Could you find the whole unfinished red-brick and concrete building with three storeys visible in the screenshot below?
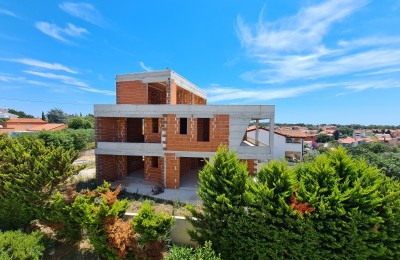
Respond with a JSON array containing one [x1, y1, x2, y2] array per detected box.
[[94, 69, 275, 189]]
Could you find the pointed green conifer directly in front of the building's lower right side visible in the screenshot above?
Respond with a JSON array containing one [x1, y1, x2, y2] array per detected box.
[[189, 147, 248, 247]]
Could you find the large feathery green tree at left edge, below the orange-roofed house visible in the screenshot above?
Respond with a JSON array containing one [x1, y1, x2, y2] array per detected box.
[[0, 136, 84, 229]]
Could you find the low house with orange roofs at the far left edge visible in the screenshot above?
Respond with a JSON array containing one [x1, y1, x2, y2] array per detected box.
[[0, 118, 67, 136]]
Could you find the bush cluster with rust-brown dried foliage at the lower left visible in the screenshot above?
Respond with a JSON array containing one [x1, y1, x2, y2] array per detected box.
[[47, 183, 173, 259]]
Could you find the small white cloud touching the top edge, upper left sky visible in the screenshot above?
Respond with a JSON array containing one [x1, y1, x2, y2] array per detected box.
[[59, 2, 104, 26]]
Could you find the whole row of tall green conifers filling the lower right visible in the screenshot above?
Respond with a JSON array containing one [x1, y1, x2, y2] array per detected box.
[[190, 148, 400, 259]]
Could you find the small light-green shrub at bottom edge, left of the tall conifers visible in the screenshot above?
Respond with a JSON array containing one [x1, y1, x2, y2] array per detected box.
[[165, 242, 221, 260]]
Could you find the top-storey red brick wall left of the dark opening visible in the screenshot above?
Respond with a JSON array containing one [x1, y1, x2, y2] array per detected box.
[[117, 80, 148, 104]]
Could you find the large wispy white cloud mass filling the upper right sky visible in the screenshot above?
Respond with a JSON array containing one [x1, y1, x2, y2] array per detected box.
[[237, 0, 400, 88]]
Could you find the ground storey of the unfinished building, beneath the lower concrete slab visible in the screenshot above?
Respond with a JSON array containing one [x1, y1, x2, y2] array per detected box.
[[96, 153, 257, 190]]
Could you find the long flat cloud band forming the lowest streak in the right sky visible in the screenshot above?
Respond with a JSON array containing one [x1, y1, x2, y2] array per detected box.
[[242, 48, 400, 84]]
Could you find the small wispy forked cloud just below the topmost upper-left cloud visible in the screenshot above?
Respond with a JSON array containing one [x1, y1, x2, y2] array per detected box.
[[35, 22, 88, 43]]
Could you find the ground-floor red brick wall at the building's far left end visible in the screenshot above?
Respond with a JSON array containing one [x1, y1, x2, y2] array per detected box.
[[96, 154, 127, 183]]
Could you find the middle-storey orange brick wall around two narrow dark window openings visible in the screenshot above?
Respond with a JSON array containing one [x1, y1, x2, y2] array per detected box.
[[164, 115, 229, 152]]
